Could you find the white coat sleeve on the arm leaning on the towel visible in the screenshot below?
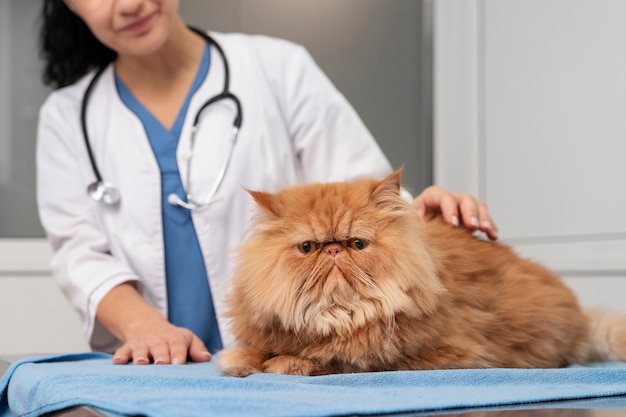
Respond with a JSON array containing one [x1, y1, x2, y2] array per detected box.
[[37, 92, 137, 349]]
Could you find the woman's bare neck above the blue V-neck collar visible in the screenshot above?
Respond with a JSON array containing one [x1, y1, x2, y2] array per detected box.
[[115, 19, 205, 86]]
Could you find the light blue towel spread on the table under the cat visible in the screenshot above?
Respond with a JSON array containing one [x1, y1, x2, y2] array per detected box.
[[0, 353, 626, 417]]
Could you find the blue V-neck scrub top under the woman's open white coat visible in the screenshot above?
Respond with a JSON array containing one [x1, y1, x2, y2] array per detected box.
[[115, 44, 222, 353]]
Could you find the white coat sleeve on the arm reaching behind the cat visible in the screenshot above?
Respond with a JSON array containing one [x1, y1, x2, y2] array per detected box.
[[264, 46, 391, 181]]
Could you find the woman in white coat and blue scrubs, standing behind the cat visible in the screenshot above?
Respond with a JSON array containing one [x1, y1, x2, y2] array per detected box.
[[37, 0, 497, 364]]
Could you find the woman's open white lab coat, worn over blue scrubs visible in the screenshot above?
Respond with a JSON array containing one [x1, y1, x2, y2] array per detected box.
[[37, 33, 391, 352]]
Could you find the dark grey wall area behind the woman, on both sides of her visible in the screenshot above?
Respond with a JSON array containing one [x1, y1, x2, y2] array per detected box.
[[0, 0, 432, 238]]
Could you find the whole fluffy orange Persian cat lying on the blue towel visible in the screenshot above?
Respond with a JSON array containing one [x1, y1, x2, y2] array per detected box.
[[217, 169, 626, 376]]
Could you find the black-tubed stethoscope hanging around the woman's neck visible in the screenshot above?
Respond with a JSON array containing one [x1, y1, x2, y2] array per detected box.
[[80, 28, 243, 210]]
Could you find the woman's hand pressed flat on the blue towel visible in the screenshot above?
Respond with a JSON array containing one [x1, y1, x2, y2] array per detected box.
[[113, 319, 211, 365]]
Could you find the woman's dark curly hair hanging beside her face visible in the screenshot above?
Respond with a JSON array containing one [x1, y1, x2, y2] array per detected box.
[[39, 0, 117, 88]]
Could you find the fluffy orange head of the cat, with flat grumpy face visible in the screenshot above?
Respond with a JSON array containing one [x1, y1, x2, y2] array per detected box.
[[234, 172, 443, 337]]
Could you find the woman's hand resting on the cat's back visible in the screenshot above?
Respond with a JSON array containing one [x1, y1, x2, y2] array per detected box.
[[413, 185, 498, 240]]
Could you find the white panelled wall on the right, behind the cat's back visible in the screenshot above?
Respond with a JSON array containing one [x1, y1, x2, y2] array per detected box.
[[434, 0, 626, 311]]
